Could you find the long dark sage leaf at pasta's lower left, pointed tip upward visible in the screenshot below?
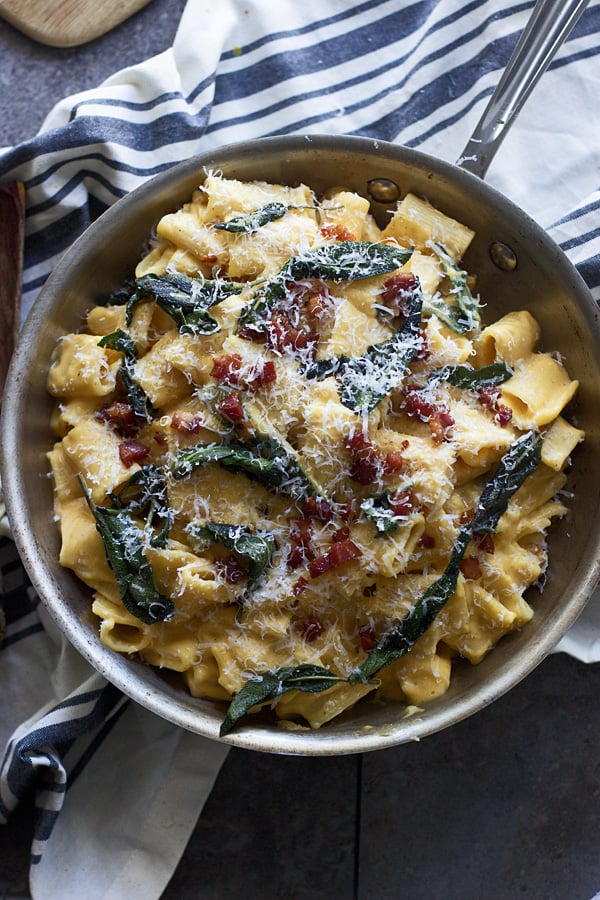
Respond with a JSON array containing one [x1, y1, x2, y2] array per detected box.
[[78, 475, 175, 625]]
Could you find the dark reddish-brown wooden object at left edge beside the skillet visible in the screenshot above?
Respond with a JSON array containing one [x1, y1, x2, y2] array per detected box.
[[0, 181, 25, 402]]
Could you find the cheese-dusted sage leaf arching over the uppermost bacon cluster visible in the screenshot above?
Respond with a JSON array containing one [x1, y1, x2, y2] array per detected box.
[[238, 241, 412, 333]]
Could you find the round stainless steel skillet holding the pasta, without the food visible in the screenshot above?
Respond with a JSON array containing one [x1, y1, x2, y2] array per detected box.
[[2, 2, 600, 755]]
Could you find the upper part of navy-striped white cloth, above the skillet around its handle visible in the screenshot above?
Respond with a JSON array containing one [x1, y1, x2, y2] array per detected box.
[[0, 0, 600, 320]]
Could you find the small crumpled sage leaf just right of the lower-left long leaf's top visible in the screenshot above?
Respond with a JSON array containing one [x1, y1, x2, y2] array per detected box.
[[110, 464, 173, 547]]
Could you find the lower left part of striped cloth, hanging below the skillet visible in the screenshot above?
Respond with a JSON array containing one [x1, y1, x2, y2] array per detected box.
[[0, 538, 227, 900]]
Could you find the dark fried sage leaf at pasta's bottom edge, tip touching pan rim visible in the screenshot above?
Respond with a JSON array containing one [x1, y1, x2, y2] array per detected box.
[[219, 663, 345, 737]]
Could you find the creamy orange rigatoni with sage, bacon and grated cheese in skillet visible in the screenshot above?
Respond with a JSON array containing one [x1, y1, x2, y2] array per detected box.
[[48, 173, 584, 734]]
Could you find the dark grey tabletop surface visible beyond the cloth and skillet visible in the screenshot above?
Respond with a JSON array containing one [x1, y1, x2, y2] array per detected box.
[[0, 0, 600, 900]]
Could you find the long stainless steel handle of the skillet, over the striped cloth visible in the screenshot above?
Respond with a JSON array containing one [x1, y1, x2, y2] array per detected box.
[[457, 0, 589, 178]]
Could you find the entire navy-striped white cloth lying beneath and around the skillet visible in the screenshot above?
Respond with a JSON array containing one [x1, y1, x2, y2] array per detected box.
[[0, 0, 600, 900]]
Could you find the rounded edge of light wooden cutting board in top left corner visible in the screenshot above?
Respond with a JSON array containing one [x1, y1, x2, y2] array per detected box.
[[0, 0, 155, 47]]
